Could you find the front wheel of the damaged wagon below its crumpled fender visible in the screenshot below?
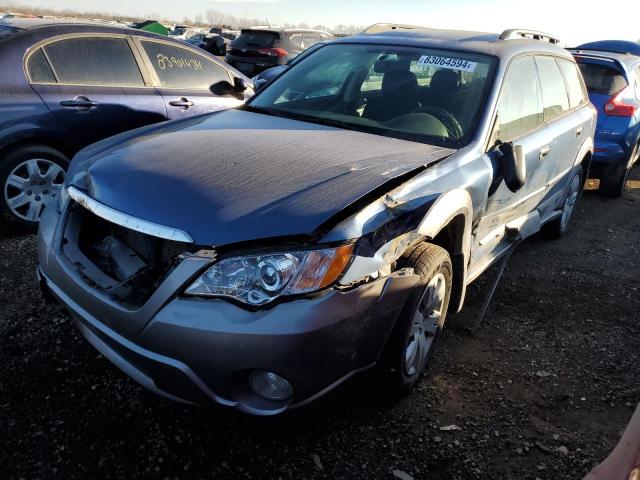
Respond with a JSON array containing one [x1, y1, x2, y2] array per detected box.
[[378, 243, 453, 398]]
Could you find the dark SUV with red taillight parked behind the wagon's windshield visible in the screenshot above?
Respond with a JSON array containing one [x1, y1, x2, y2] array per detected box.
[[225, 27, 333, 76]]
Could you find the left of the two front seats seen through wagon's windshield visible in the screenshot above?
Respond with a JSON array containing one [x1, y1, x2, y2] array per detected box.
[[362, 70, 419, 122]]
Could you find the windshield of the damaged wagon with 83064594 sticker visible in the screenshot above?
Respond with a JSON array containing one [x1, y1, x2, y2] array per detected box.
[[249, 44, 495, 146]]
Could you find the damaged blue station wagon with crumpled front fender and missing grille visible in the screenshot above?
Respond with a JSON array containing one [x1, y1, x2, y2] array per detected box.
[[39, 26, 596, 415]]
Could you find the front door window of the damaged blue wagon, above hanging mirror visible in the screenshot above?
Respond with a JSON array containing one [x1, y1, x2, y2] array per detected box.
[[498, 57, 543, 142]]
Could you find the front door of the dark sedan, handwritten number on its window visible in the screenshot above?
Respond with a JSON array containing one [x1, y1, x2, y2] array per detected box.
[[136, 38, 244, 120]]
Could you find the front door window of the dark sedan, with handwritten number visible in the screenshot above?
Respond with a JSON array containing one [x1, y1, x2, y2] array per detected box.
[[142, 41, 229, 90]]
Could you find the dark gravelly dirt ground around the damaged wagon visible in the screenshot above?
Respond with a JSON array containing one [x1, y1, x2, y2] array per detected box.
[[0, 168, 640, 480]]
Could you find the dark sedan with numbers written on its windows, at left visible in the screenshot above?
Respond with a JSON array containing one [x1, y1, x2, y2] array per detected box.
[[0, 19, 253, 229]]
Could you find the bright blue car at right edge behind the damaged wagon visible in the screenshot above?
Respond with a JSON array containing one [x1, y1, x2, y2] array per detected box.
[[572, 40, 640, 197]]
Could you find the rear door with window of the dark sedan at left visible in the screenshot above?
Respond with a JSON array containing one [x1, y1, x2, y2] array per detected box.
[[26, 34, 166, 145]]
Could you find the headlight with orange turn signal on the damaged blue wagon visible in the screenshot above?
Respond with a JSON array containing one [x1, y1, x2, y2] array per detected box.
[[185, 245, 353, 306]]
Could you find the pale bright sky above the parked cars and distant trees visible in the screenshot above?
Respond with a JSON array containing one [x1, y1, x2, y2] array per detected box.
[[8, 0, 640, 45]]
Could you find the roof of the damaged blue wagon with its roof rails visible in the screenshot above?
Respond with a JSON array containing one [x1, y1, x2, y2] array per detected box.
[[334, 24, 572, 58]]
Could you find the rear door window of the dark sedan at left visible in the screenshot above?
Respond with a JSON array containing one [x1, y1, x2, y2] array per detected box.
[[42, 37, 144, 87]]
